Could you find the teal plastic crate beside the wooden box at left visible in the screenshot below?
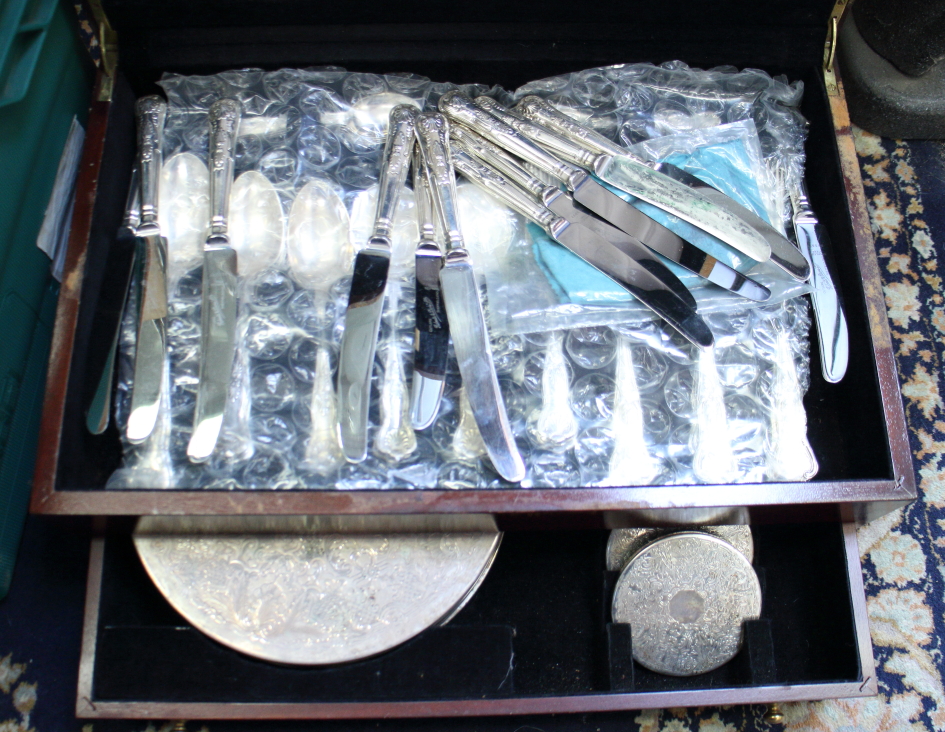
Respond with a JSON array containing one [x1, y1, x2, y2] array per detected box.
[[0, 0, 92, 598]]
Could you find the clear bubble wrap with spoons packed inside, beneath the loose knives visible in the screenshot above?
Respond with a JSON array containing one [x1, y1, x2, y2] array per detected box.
[[109, 64, 812, 489]]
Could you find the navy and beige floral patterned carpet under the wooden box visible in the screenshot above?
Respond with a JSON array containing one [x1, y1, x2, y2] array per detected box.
[[0, 131, 945, 732]]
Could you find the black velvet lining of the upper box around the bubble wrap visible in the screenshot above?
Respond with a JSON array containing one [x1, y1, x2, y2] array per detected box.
[[56, 0, 893, 490]]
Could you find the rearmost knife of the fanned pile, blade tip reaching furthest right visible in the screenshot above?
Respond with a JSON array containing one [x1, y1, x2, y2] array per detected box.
[[514, 95, 810, 280]]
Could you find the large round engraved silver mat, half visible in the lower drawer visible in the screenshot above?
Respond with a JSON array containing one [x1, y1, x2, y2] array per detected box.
[[134, 519, 501, 665]]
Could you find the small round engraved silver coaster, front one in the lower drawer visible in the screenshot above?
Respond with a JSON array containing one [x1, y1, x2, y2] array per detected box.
[[612, 532, 761, 676]]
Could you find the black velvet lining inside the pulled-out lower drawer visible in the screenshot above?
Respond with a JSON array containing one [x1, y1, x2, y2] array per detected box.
[[93, 523, 860, 702]]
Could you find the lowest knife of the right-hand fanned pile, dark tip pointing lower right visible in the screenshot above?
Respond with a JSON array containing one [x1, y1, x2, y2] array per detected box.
[[453, 149, 713, 348]]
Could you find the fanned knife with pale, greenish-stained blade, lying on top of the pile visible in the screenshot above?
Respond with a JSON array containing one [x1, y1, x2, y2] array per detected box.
[[466, 97, 771, 262]]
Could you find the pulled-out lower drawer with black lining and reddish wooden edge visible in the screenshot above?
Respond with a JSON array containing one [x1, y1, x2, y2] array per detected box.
[[78, 522, 874, 719]]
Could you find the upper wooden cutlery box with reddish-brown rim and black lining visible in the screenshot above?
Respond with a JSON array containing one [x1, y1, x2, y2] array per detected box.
[[32, 2, 915, 522]]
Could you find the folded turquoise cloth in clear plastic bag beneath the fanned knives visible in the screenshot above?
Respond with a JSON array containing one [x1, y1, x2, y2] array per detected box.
[[528, 139, 770, 305]]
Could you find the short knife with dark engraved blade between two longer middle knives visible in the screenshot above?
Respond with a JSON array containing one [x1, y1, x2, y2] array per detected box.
[[410, 145, 450, 430]]
